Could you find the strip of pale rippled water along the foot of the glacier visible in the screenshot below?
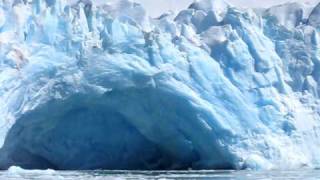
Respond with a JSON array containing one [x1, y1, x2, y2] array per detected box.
[[0, 170, 320, 180]]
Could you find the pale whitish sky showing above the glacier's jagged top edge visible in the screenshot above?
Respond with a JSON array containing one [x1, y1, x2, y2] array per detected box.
[[131, 0, 320, 17]]
